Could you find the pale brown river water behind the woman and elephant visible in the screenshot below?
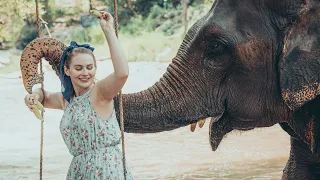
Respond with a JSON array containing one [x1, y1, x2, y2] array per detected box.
[[0, 62, 289, 180]]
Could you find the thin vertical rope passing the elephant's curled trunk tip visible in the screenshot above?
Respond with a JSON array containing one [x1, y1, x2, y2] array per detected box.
[[36, 0, 44, 180]]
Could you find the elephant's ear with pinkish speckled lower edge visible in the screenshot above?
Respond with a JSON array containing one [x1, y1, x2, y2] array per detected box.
[[279, 5, 320, 111]]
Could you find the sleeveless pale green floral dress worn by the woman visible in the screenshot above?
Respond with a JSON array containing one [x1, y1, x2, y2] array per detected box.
[[60, 89, 132, 180]]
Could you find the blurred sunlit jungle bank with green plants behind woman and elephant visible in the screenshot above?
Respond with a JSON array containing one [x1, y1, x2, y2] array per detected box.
[[0, 0, 213, 73]]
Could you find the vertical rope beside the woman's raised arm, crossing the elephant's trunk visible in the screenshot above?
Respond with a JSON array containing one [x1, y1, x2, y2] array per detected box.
[[113, 0, 127, 180]]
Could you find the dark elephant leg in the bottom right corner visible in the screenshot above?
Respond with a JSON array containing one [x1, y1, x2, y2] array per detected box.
[[282, 137, 320, 180]]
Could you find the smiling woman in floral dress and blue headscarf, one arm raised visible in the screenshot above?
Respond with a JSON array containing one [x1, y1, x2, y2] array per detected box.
[[25, 12, 132, 180]]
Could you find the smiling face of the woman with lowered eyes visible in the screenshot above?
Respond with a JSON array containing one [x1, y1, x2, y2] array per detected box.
[[65, 53, 96, 92]]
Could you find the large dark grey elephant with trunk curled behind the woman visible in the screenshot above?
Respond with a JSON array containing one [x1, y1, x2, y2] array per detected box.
[[21, 0, 320, 180]]
